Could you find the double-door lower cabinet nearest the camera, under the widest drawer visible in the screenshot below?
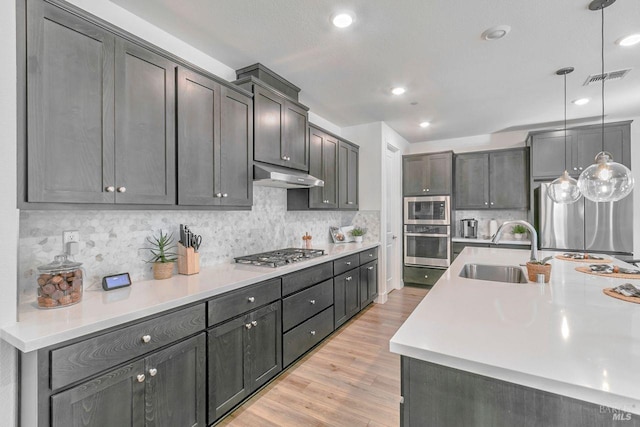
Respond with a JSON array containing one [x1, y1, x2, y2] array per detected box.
[[51, 333, 207, 427]]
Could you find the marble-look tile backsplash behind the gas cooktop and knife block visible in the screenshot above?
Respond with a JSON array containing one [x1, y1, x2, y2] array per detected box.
[[18, 186, 380, 302]]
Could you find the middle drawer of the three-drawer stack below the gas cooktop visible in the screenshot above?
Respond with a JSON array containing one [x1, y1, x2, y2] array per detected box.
[[282, 279, 333, 331]]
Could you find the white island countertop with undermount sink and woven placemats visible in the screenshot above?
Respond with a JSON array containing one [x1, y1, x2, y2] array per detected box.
[[390, 247, 640, 414]]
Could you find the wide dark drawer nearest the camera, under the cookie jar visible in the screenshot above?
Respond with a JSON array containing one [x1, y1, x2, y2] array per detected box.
[[51, 304, 205, 390]]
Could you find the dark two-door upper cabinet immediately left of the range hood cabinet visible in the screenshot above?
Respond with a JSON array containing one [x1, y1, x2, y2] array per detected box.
[[178, 68, 253, 206]]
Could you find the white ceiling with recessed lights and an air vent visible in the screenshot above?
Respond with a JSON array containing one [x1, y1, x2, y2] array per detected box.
[[112, 0, 640, 142]]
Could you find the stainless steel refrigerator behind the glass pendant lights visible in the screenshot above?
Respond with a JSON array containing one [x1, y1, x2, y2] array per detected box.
[[535, 183, 633, 257]]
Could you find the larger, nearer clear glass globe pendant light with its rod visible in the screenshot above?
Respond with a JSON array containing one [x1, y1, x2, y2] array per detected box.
[[578, 0, 633, 202]]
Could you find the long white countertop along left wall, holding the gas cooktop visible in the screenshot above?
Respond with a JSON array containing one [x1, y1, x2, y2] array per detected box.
[[0, 242, 378, 353]]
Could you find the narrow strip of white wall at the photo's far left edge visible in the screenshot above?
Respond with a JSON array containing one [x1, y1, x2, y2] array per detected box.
[[0, 1, 18, 426]]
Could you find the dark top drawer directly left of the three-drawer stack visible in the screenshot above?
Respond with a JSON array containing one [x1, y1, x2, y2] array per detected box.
[[207, 278, 280, 326]]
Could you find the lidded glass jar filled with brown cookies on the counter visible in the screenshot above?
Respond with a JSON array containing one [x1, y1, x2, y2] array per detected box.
[[37, 255, 84, 308]]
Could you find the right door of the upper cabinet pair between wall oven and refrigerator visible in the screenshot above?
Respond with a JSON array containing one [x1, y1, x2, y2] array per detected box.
[[489, 149, 529, 209]]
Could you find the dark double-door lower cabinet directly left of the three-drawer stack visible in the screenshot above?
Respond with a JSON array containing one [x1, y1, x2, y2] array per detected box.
[[207, 301, 282, 423]]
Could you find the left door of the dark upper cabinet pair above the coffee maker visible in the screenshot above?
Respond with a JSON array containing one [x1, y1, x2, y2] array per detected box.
[[455, 153, 489, 209]]
